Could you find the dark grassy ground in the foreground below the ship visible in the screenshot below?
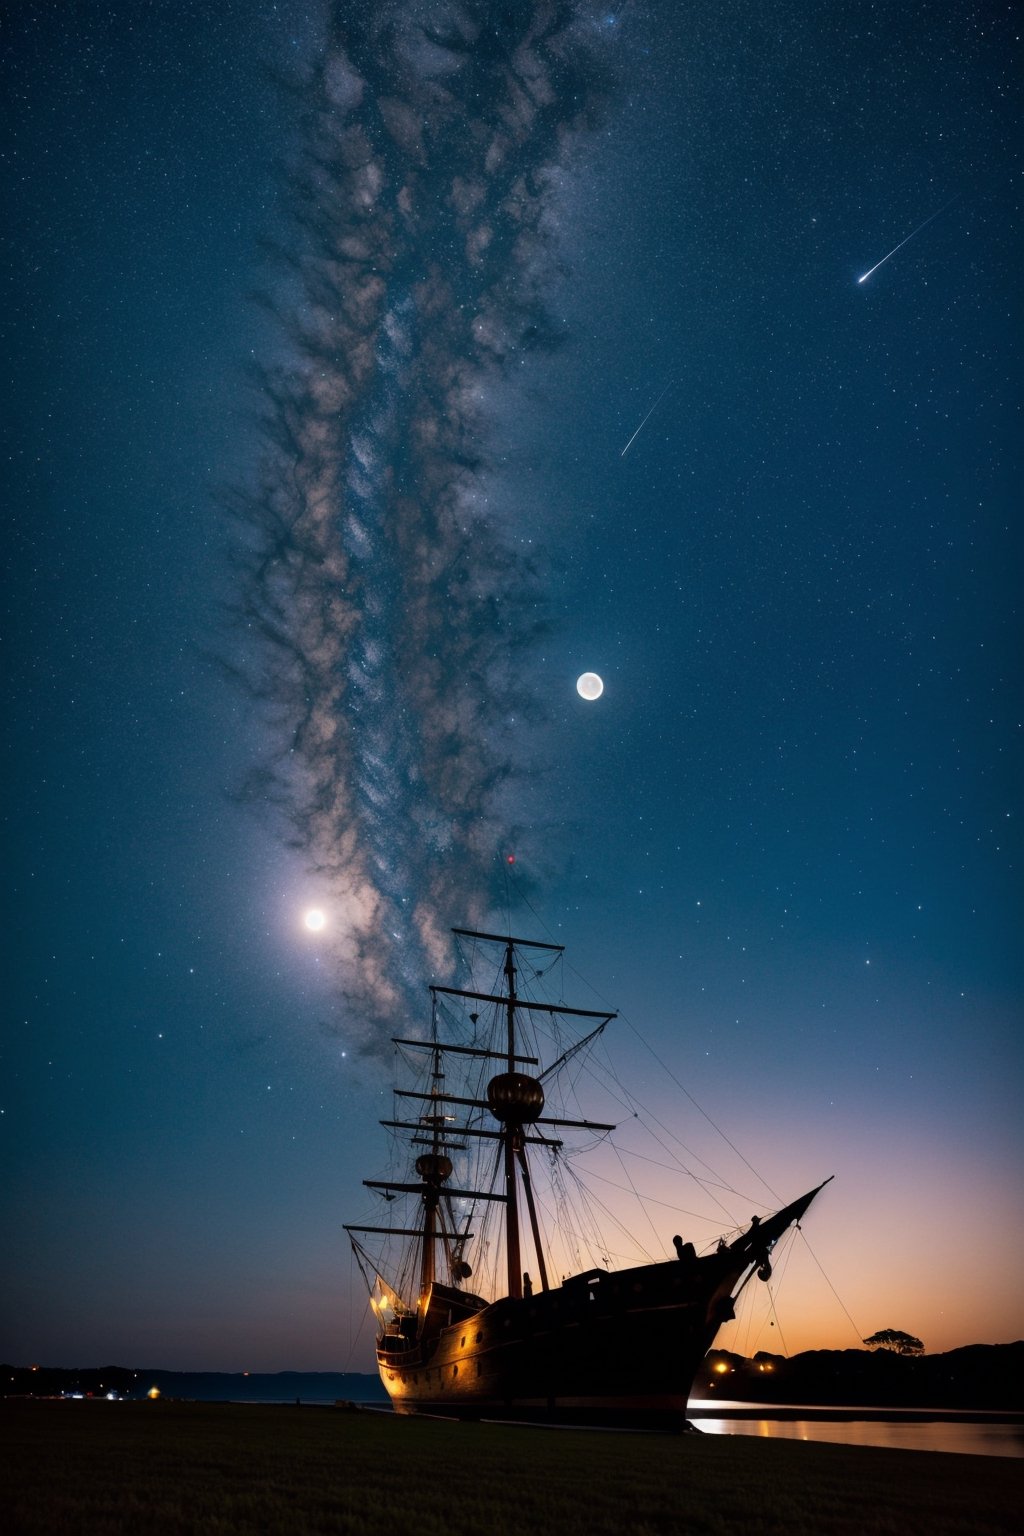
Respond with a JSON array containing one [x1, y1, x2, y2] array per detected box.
[[0, 1401, 1024, 1536]]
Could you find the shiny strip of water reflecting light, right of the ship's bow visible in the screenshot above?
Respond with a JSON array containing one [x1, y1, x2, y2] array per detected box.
[[689, 1401, 1024, 1458]]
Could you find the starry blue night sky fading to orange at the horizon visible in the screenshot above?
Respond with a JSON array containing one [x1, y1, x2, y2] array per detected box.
[[0, 0, 1024, 1370]]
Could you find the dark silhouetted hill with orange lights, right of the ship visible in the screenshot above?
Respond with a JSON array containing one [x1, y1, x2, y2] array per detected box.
[[691, 1341, 1024, 1412]]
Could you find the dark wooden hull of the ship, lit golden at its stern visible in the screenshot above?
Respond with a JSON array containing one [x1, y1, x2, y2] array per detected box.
[[378, 1253, 743, 1427]]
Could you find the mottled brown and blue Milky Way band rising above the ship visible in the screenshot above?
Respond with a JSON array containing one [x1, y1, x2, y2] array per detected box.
[[233, 0, 597, 1048]]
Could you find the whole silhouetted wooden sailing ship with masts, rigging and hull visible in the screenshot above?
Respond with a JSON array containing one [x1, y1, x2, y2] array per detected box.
[[345, 928, 827, 1427]]
